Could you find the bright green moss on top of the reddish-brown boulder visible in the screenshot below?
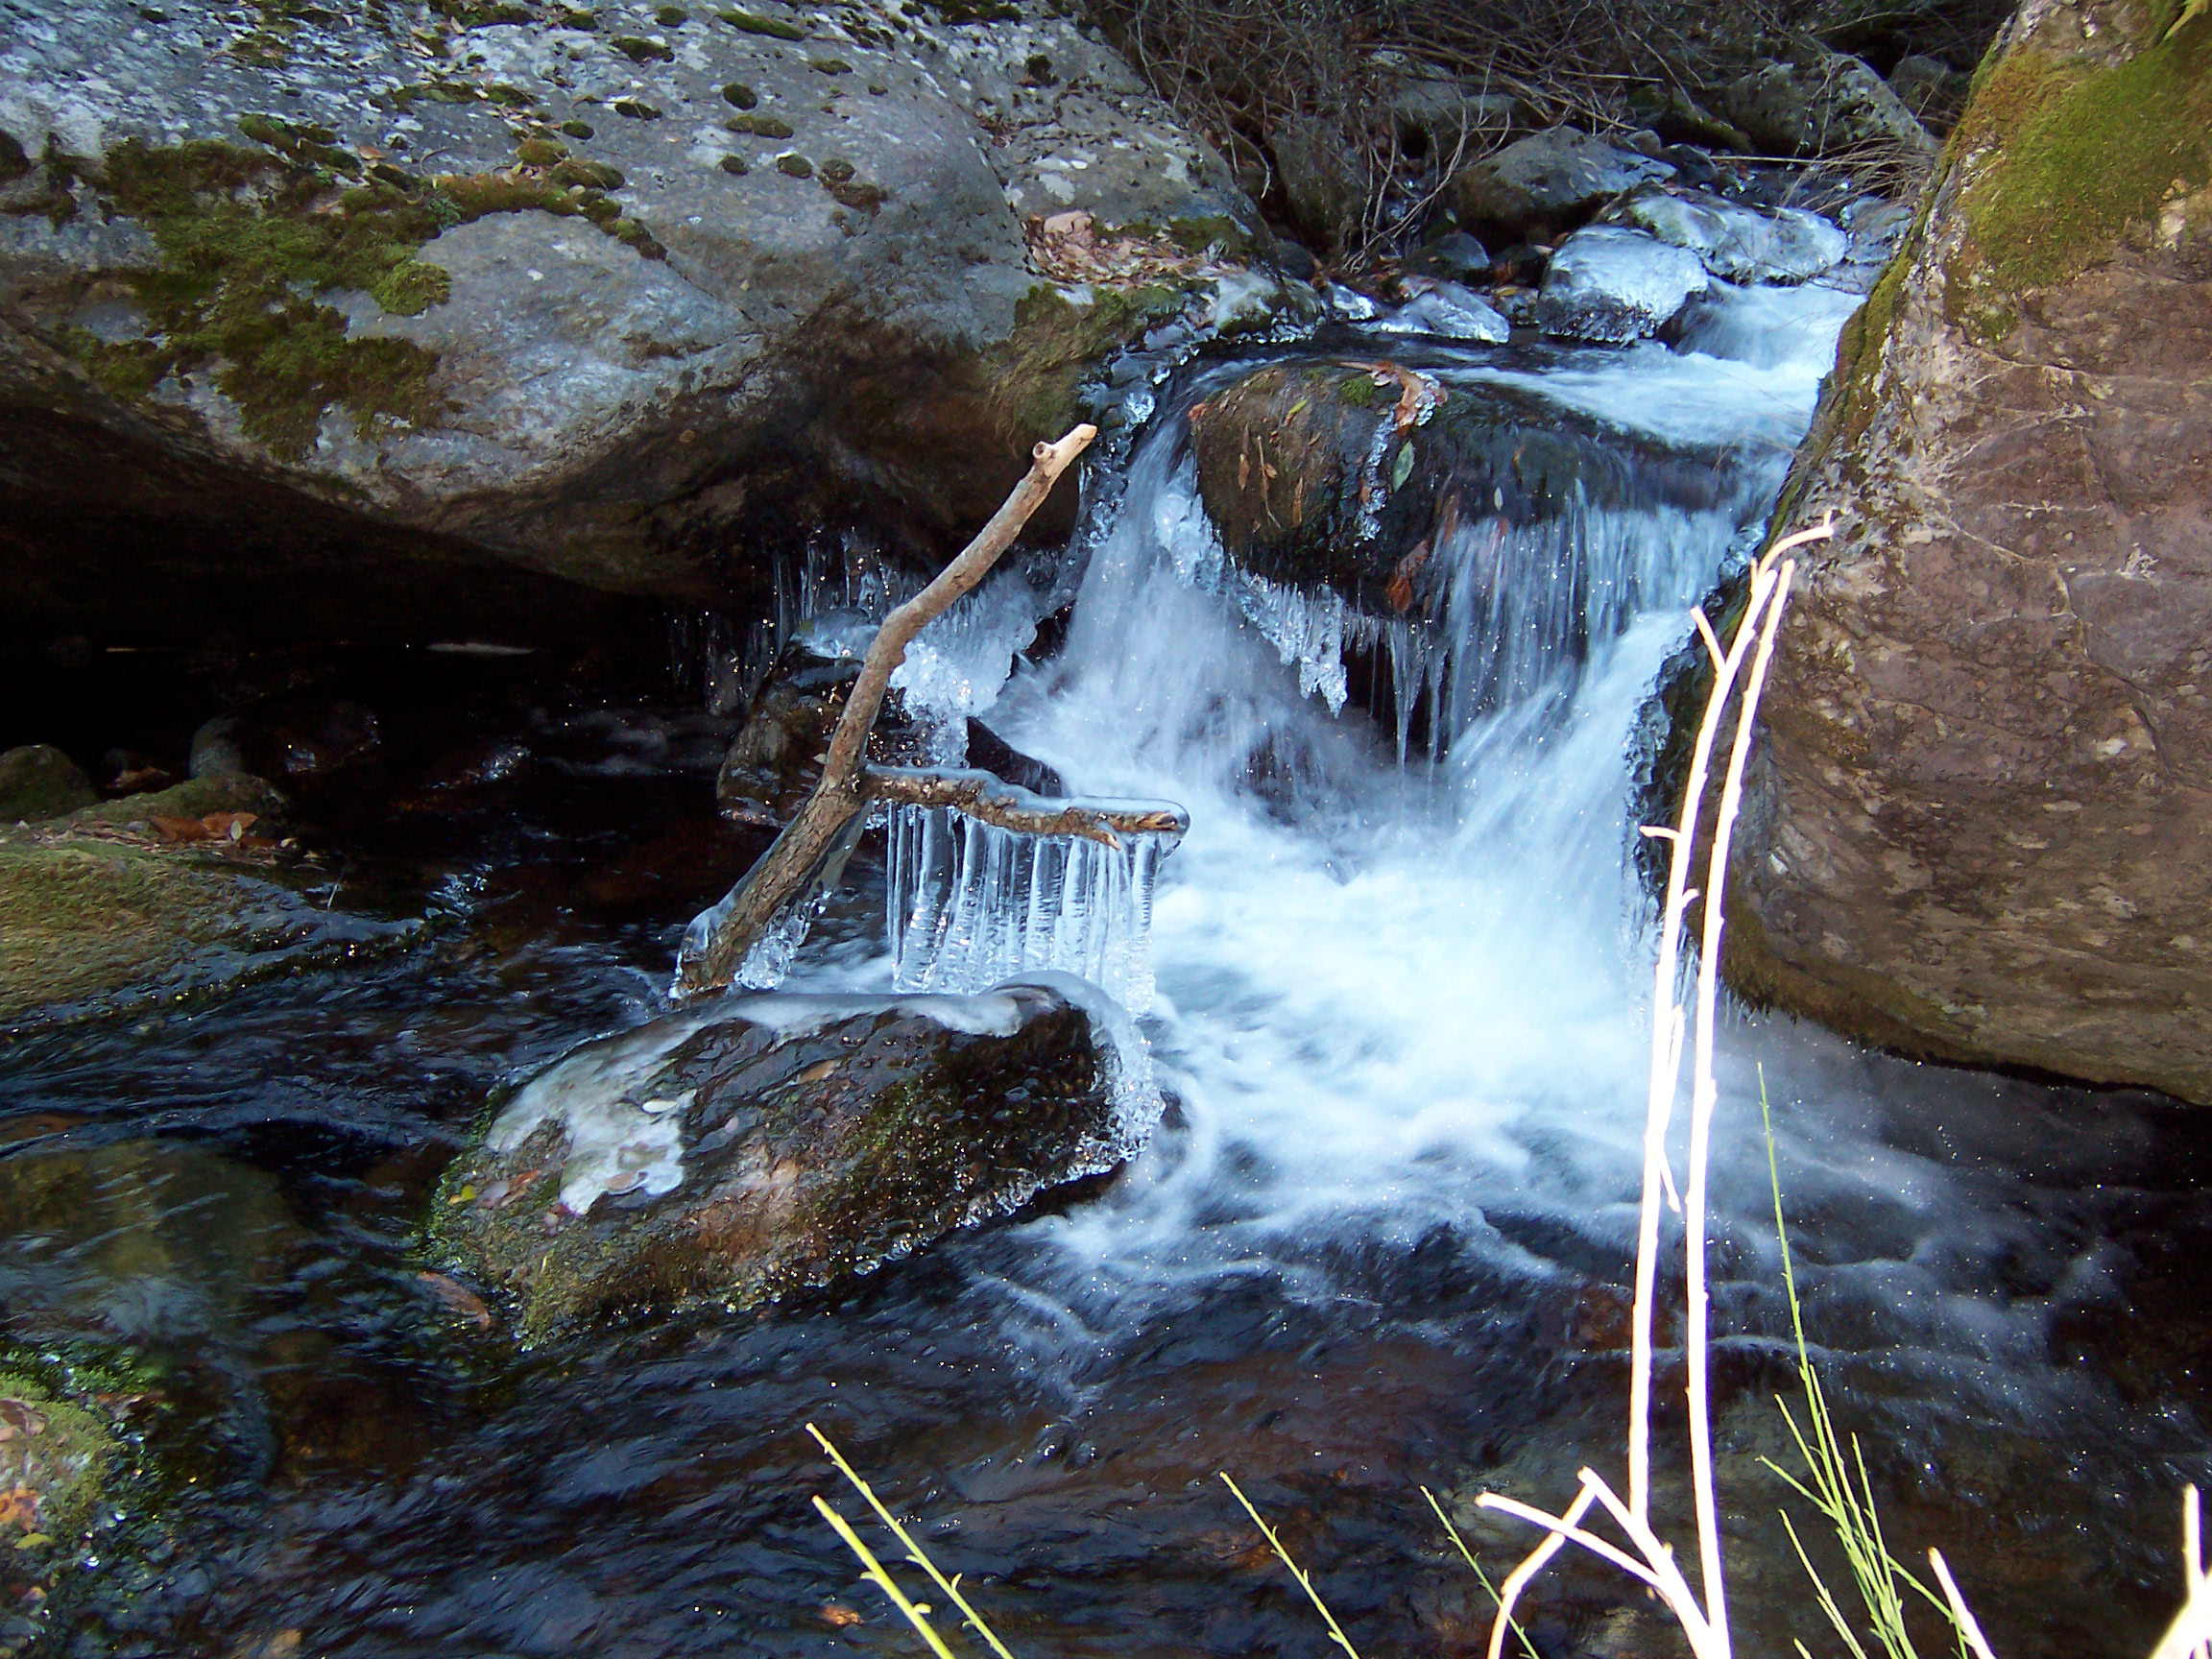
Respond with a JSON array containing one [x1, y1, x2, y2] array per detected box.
[[1947, 15, 2212, 321]]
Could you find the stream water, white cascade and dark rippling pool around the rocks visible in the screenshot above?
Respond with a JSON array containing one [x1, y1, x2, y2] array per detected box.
[[0, 290, 2212, 1659]]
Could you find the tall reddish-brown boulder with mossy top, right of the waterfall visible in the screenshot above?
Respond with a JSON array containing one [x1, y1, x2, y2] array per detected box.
[[1727, 0, 2212, 1101]]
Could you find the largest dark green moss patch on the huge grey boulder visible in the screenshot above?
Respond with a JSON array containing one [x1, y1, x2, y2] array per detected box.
[[49, 129, 663, 460]]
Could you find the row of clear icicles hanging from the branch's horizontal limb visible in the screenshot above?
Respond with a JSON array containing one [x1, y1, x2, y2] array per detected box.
[[887, 805, 1181, 1013]]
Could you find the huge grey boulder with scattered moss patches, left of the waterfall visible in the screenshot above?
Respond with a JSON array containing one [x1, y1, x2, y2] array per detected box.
[[0, 0, 1257, 633]]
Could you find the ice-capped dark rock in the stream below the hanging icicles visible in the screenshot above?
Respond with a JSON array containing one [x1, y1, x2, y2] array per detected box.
[[431, 975, 1148, 1338]]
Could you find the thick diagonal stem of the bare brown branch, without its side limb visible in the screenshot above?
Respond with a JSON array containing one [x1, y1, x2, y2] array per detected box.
[[672, 424, 1097, 999]]
